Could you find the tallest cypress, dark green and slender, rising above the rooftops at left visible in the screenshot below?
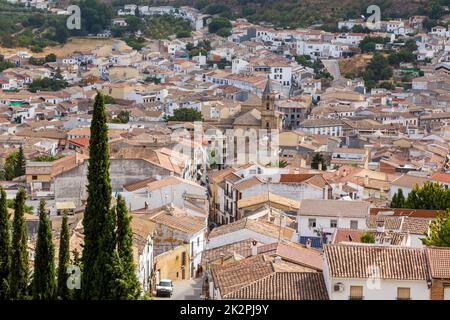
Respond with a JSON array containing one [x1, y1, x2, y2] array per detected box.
[[81, 92, 114, 299]]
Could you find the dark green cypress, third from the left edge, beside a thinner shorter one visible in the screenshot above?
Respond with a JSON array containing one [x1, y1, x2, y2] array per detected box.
[[33, 199, 56, 300]]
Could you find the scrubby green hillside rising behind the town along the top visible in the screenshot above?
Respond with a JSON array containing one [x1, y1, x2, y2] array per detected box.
[[127, 0, 426, 27]]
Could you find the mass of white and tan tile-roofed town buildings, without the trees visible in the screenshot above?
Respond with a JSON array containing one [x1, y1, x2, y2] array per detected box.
[[0, 0, 450, 300]]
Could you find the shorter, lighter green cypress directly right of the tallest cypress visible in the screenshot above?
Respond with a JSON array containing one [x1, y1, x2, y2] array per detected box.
[[114, 195, 140, 299]]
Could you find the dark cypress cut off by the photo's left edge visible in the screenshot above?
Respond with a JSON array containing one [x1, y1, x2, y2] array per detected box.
[[0, 188, 11, 300]]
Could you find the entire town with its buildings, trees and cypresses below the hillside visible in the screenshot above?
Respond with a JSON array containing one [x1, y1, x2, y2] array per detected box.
[[0, 0, 450, 300]]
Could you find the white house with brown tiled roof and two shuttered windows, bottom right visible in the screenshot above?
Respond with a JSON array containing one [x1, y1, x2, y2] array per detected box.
[[323, 244, 431, 300]]
